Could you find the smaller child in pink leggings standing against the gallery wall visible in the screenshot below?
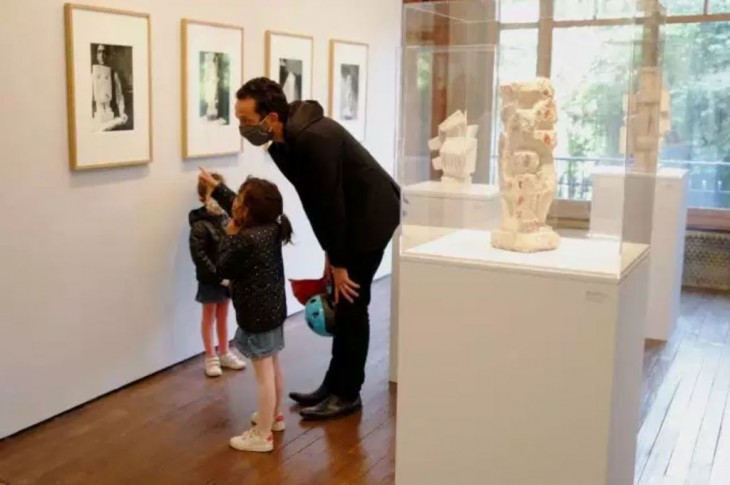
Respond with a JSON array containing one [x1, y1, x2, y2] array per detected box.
[[188, 173, 246, 377]]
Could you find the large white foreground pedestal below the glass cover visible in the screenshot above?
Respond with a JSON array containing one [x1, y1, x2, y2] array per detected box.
[[396, 231, 649, 485]]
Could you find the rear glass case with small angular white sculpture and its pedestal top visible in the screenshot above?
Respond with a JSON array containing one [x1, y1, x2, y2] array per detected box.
[[398, 45, 499, 246]]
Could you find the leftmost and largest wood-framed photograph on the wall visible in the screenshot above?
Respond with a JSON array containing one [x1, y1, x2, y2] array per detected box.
[[64, 4, 152, 170]]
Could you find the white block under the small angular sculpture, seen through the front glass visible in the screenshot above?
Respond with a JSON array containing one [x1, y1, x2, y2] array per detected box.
[[403, 181, 500, 230]]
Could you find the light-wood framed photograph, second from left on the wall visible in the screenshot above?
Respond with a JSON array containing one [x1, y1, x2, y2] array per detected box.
[[182, 19, 243, 158]]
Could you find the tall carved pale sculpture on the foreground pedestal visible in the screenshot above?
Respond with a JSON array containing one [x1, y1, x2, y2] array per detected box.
[[492, 78, 560, 252]]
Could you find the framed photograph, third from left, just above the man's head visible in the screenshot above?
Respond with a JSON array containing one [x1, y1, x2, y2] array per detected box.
[[265, 31, 314, 103]]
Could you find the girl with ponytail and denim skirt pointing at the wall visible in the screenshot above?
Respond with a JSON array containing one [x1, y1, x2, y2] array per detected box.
[[201, 172, 292, 452]]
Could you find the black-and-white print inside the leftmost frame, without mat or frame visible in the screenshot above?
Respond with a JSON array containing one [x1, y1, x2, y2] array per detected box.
[[91, 43, 134, 133]]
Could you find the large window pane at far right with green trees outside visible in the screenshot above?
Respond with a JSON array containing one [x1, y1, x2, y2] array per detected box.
[[660, 22, 730, 209]]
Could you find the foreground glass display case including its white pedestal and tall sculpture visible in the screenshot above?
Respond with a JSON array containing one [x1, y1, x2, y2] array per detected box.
[[391, 4, 668, 485]]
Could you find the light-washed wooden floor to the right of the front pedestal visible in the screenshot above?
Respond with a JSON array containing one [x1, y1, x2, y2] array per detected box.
[[636, 292, 730, 485]]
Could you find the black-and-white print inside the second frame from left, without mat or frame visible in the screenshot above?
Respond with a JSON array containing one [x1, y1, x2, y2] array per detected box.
[[199, 51, 231, 125]]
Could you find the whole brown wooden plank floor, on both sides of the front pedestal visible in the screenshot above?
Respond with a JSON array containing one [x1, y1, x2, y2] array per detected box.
[[0, 281, 730, 485]]
